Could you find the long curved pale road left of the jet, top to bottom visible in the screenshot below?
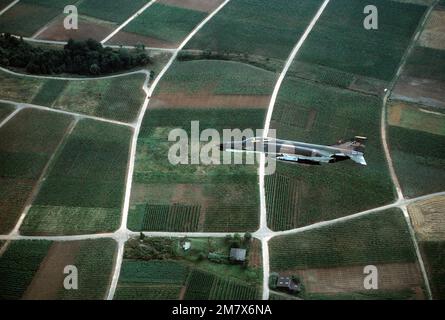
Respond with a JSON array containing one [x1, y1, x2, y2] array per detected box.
[[107, 0, 230, 300]]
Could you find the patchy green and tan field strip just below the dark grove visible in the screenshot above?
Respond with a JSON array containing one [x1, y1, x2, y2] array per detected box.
[[0, 72, 146, 122]]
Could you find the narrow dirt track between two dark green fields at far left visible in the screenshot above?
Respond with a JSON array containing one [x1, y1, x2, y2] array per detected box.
[[11, 117, 79, 235]]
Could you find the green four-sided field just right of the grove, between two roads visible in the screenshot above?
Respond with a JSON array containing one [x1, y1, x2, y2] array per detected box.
[[110, 3, 207, 48]]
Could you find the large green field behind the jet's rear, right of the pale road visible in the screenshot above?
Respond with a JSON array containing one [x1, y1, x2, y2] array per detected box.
[[266, 77, 394, 230]]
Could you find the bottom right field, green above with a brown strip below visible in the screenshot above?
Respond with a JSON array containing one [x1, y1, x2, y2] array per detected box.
[[269, 209, 424, 299]]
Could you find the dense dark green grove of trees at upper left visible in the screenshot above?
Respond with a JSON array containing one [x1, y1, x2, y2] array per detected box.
[[0, 34, 151, 75]]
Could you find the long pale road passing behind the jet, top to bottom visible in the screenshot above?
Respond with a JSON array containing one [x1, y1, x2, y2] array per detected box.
[[258, 0, 330, 300]]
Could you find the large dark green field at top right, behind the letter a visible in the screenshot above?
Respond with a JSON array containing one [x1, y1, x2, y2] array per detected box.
[[297, 0, 426, 81]]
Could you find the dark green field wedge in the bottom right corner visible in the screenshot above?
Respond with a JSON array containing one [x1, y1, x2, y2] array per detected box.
[[420, 241, 445, 300]]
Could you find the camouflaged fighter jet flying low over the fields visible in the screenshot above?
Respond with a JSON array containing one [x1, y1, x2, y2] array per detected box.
[[220, 136, 367, 166]]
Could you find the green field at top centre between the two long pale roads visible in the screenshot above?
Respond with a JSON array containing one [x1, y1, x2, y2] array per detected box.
[[186, 0, 322, 60]]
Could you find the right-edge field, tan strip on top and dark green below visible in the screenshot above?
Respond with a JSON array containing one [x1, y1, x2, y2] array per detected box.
[[388, 102, 445, 197]]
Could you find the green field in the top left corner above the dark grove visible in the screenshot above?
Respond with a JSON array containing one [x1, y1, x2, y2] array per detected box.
[[0, 0, 71, 36]]
